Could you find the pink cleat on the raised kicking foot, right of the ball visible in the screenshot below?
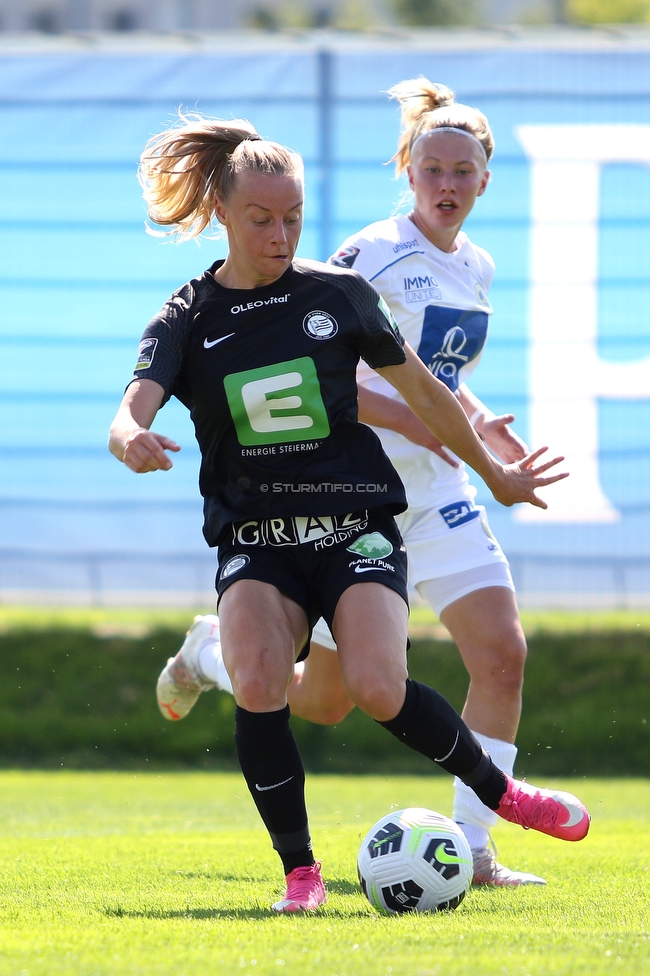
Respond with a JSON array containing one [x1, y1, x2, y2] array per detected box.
[[496, 776, 591, 840]]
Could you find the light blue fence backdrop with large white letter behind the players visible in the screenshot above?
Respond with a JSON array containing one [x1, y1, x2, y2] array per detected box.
[[0, 41, 650, 605]]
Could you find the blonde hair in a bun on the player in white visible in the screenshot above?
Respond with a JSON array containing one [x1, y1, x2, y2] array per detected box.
[[388, 78, 494, 176]]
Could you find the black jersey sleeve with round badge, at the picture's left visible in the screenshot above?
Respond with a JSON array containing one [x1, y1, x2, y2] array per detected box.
[[131, 293, 190, 403]]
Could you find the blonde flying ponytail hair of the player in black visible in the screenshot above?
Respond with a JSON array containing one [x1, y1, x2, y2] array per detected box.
[[138, 112, 303, 240]]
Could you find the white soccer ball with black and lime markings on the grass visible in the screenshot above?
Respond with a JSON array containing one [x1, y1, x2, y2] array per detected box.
[[357, 807, 474, 914]]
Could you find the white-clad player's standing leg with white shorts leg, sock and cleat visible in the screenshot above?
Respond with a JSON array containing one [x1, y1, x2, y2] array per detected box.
[[398, 504, 543, 885]]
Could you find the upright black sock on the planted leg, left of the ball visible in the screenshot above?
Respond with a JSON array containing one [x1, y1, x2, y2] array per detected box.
[[235, 705, 314, 874]]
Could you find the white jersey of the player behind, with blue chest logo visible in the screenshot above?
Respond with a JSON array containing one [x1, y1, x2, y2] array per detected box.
[[330, 214, 494, 510]]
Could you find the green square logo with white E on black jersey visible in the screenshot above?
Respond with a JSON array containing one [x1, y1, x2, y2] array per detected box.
[[223, 356, 330, 445]]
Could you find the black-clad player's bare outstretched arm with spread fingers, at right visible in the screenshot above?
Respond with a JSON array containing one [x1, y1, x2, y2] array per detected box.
[[377, 344, 567, 508]]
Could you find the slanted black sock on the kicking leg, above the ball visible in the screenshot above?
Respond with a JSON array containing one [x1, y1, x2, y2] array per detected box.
[[379, 678, 507, 810]]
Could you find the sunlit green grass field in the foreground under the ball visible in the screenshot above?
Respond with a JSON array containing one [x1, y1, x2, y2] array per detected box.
[[0, 771, 650, 976]]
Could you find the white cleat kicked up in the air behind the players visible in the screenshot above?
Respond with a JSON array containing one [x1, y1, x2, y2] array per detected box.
[[156, 613, 219, 722]]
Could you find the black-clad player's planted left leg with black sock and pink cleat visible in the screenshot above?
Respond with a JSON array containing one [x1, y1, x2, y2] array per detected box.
[[219, 579, 325, 912]]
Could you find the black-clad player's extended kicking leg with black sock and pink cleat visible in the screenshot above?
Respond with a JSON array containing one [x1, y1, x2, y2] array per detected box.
[[332, 582, 589, 840]]
